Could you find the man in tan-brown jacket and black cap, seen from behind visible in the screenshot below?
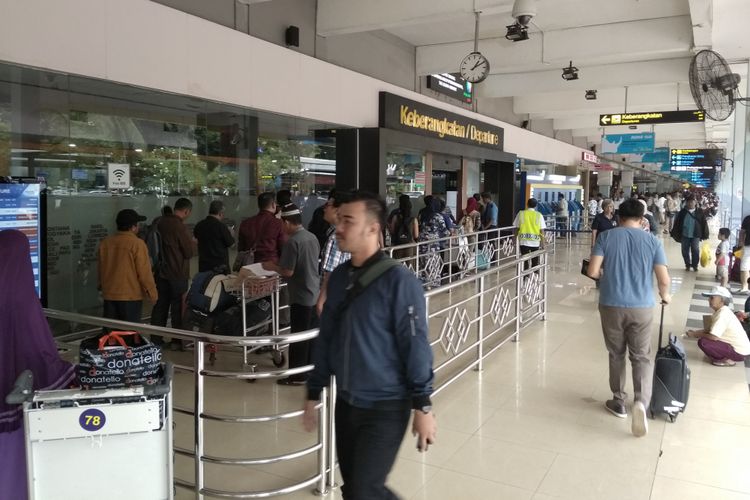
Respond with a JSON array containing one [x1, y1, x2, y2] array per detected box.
[[99, 208, 157, 323]]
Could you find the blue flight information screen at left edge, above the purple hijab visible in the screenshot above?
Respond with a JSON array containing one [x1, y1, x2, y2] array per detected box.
[[0, 183, 43, 299]]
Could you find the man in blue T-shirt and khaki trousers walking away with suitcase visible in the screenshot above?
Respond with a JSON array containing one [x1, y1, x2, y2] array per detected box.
[[588, 198, 670, 437]]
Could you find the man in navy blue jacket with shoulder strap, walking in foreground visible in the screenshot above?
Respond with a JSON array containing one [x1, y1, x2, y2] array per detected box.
[[303, 192, 436, 500]]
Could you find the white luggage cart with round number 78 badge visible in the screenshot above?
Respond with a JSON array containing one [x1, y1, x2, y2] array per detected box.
[[6, 364, 174, 500]]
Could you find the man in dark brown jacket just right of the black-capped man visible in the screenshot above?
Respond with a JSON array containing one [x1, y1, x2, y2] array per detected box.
[[151, 198, 195, 348]]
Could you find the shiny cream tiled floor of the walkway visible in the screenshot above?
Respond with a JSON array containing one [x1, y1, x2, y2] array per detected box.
[[172, 235, 750, 500]]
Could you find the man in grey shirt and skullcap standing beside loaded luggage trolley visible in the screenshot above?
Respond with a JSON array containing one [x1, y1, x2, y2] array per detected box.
[[263, 203, 320, 385]]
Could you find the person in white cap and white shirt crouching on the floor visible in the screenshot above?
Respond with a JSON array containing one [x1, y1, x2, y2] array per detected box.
[[686, 286, 750, 366]]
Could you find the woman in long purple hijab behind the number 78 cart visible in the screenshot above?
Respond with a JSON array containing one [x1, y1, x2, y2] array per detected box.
[[0, 231, 75, 500]]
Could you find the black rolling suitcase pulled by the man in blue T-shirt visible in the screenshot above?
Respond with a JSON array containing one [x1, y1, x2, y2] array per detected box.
[[649, 304, 690, 422]]
